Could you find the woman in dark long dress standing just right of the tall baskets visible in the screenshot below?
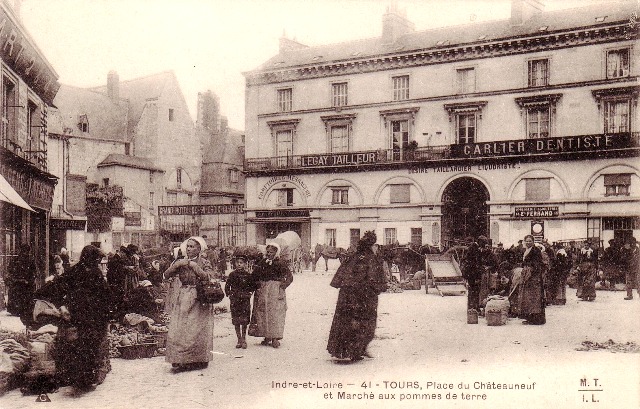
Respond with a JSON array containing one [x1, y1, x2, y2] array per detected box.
[[519, 235, 546, 325]]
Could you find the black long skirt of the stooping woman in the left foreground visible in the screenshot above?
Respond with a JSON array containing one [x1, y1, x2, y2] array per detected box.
[[52, 325, 111, 387]]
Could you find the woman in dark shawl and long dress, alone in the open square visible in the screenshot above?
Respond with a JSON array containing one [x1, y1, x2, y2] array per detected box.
[[327, 231, 387, 361]]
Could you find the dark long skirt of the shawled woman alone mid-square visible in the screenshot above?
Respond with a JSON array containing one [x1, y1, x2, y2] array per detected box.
[[327, 288, 378, 358]]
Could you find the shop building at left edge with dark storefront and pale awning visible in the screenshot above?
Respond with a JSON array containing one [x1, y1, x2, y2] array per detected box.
[[0, 1, 60, 284]]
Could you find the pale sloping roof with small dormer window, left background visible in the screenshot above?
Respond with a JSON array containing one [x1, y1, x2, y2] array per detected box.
[[47, 85, 128, 142]]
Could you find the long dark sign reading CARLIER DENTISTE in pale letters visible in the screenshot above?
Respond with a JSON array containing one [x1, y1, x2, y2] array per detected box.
[[451, 133, 633, 158]]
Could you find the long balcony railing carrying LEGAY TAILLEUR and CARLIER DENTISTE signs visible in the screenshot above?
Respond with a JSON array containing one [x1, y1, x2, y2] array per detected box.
[[244, 132, 640, 172]]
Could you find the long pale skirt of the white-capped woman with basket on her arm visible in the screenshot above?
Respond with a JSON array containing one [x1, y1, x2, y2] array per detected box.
[[165, 285, 213, 364]]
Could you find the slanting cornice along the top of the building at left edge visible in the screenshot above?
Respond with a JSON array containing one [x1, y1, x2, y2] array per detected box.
[[0, 8, 60, 105]]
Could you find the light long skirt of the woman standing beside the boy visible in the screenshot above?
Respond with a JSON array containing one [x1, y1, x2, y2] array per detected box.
[[249, 281, 287, 339]]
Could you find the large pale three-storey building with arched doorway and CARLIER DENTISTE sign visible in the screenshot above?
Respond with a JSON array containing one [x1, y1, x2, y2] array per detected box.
[[245, 0, 640, 247]]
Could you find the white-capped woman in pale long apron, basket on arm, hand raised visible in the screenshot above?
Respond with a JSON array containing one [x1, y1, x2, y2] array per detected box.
[[164, 236, 214, 372]]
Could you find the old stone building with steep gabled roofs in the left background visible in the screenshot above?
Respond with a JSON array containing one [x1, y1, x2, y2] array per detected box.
[[50, 71, 202, 254]]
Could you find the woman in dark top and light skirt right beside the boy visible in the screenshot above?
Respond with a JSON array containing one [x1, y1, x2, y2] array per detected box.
[[249, 242, 293, 348]]
